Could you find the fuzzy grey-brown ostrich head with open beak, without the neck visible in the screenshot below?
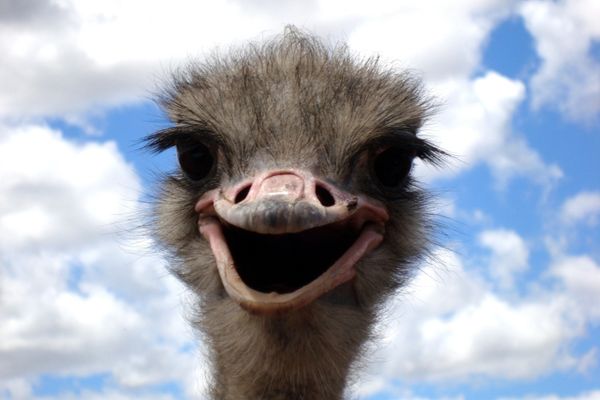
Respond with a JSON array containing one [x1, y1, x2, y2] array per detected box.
[[148, 32, 437, 314]]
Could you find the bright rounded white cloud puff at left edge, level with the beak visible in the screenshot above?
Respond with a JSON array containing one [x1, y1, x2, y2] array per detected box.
[[0, 125, 140, 253]]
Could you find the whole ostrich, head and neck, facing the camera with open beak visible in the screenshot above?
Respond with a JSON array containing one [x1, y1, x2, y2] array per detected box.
[[146, 27, 443, 400]]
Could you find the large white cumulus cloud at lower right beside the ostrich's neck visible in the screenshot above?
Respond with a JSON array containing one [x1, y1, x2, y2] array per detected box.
[[360, 242, 600, 393]]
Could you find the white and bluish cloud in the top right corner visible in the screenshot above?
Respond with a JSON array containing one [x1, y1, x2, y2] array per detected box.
[[520, 0, 600, 120]]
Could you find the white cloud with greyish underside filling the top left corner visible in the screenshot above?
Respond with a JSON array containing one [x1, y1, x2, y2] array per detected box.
[[0, 0, 290, 118]]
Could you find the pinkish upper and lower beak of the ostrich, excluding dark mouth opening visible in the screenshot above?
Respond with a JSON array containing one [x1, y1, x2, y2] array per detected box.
[[195, 169, 389, 313]]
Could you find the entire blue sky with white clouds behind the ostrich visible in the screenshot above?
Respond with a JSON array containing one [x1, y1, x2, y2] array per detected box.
[[0, 0, 600, 400]]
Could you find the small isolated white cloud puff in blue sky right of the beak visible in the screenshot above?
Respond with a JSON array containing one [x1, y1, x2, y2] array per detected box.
[[479, 229, 529, 289]]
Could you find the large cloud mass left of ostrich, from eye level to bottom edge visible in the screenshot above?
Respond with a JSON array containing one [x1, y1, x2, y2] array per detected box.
[[0, 125, 201, 398]]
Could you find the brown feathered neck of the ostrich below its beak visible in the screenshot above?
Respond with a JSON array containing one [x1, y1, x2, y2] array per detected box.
[[199, 298, 372, 400]]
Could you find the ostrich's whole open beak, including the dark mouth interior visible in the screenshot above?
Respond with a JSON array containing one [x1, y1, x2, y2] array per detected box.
[[195, 170, 389, 314]]
